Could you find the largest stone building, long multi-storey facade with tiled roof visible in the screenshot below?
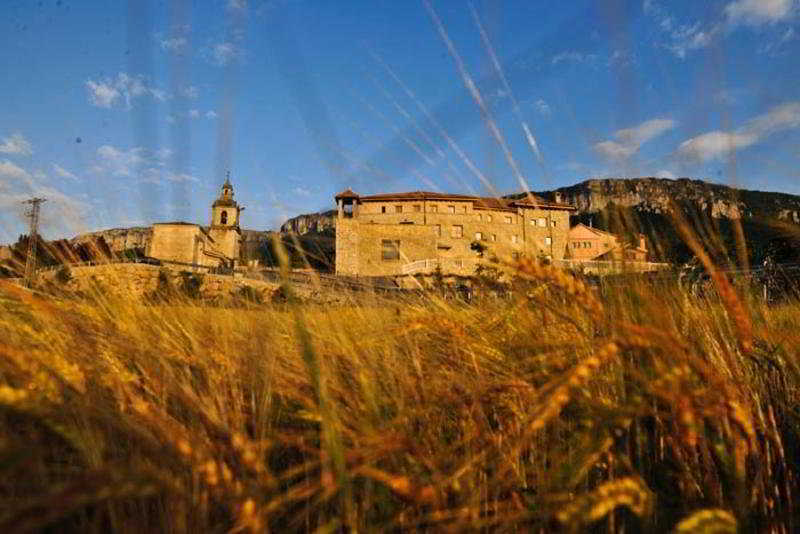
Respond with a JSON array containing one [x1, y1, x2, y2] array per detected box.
[[335, 189, 574, 276]]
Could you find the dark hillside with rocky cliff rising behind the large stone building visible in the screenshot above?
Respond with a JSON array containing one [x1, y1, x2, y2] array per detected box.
[[281, 178, 800, 263]]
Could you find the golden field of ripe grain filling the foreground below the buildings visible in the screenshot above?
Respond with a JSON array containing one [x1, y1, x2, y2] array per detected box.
[[0, 263, 800, 532]]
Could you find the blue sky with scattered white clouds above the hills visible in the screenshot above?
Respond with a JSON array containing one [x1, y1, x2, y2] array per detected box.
[[0, 0, 800, 242]]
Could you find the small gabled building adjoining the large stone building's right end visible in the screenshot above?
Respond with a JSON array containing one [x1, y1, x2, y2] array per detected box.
[[565, 224, 647, 262]]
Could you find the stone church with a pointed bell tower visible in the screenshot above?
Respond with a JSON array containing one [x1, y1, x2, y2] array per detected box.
[[146, 173, 244, 269]]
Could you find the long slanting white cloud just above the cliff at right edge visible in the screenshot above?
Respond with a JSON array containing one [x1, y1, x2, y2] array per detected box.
[[678, 102, 800, 161]]
